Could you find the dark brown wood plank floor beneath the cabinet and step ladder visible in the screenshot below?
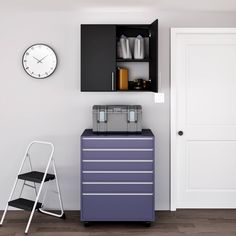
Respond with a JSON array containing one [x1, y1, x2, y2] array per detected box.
[[0, 210, 236, 236]]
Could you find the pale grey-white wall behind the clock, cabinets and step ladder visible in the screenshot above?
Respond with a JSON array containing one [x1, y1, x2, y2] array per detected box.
[[0, 3, 236, 210]]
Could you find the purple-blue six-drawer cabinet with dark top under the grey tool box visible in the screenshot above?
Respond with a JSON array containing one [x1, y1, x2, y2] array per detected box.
[[81, 129, 155, 223]]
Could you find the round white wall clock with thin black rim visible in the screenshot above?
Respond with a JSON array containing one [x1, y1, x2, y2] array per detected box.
[[22, 44, 57, 79]]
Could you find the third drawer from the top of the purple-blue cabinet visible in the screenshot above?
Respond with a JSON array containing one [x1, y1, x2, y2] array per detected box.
[[82, 160, 153, 170]]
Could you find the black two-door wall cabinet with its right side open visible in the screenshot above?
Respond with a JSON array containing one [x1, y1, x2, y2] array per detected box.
[[81, 20, 158, 92]]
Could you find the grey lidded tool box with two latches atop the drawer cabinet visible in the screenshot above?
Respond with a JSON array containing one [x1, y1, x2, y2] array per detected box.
[[93, 105, 142, 133]]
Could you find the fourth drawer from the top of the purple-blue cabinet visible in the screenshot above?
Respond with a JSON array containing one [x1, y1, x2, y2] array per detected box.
[[82, 171, 153, 182]]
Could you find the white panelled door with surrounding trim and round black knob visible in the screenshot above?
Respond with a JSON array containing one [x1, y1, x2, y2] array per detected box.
[[171, 29, 236, 208]]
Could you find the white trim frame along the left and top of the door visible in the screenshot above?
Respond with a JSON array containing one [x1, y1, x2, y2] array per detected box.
[[170, 28, 236, 211]]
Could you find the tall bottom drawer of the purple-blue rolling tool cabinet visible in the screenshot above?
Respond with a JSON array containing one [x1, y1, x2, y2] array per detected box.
[[81, 195, 154, 221]]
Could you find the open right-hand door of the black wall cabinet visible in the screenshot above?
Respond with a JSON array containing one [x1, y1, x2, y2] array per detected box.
[[149, 20, 158, 93]]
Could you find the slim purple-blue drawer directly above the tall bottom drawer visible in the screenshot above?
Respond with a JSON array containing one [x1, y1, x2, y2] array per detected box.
[[82, 182, 153, 193]]
